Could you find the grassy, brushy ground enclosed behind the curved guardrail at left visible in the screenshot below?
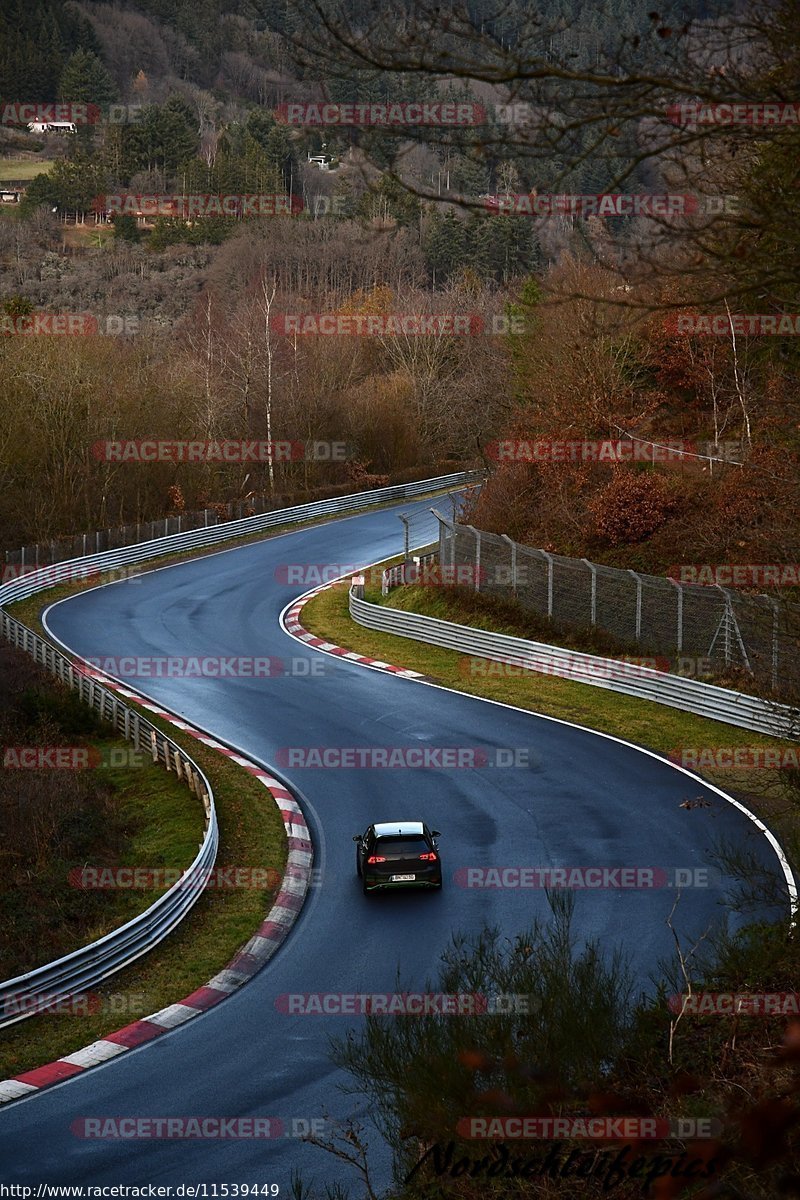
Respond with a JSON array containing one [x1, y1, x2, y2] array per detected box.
[[0, 647, 204, 978]]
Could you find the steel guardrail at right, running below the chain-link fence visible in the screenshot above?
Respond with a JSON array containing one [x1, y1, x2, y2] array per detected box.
[[349, 582, 800, 739]]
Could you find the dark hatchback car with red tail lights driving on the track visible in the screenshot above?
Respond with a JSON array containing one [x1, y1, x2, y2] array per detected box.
[[353, 821, 441, 895]]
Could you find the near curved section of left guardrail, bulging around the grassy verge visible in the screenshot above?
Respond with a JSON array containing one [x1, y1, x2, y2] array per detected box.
[[0, 612, 219, 1028]]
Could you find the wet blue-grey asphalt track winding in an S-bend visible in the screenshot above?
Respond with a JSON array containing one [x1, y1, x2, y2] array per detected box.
[[0, 500, 782, 1198]]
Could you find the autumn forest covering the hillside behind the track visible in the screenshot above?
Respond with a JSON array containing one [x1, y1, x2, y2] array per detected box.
[[0, 0, 800, 597]]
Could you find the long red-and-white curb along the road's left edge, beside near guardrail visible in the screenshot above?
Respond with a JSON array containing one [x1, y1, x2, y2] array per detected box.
[[0, 679, 313, 1104]]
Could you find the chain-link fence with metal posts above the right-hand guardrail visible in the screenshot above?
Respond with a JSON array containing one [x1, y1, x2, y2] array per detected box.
[[437, 514, 800, 698]]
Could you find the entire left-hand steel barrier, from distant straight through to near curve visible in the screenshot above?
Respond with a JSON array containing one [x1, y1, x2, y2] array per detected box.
[[0, 470, 483, 1028]]
